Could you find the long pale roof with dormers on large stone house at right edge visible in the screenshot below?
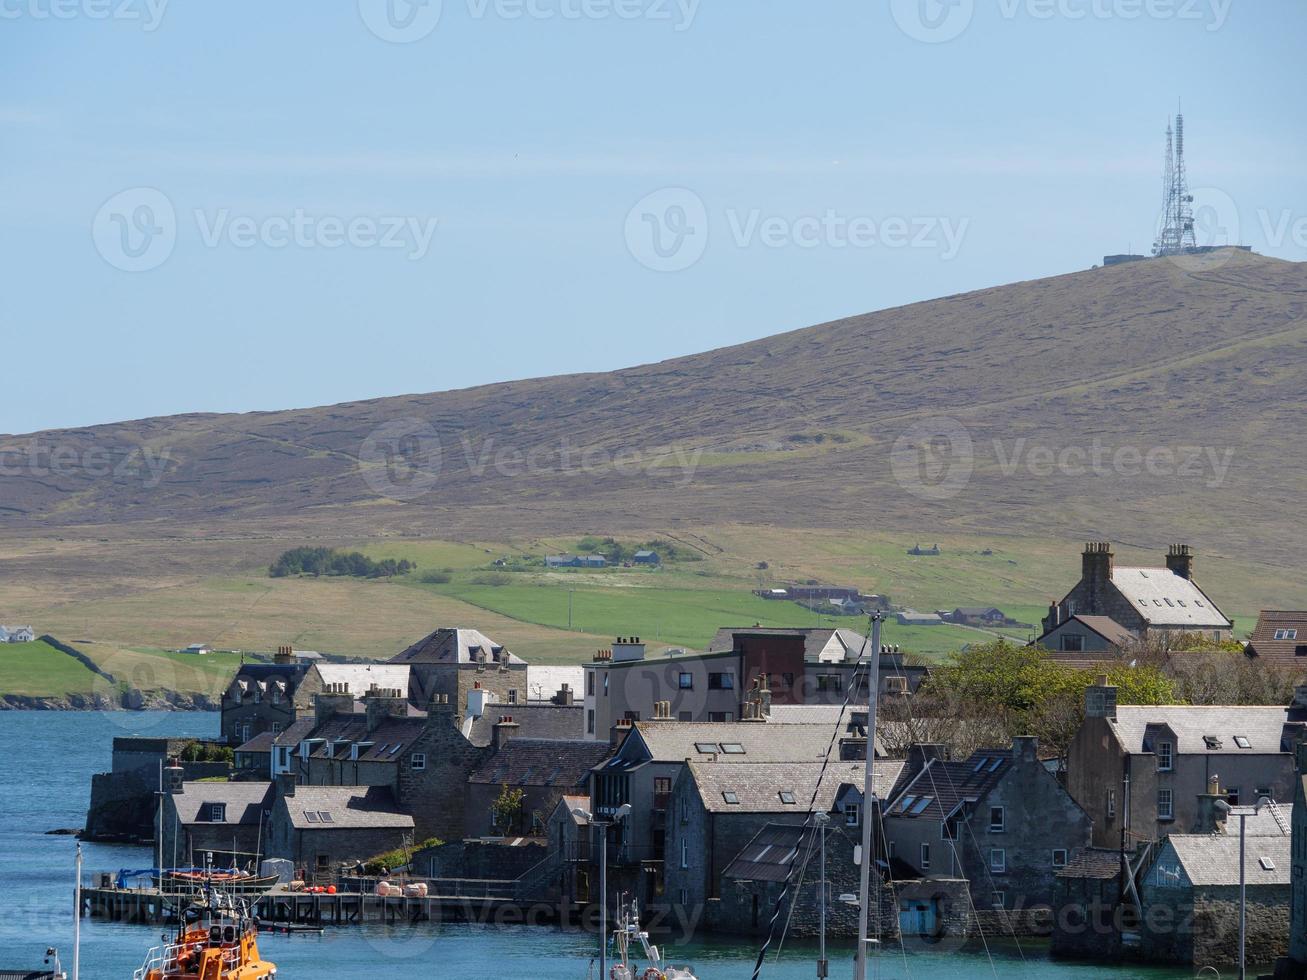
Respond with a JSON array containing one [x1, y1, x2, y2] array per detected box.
[[1108, 704, 1293, 755]]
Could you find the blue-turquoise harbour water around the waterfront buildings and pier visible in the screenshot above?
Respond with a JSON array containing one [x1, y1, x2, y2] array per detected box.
[[0, 712, 1192, 980]]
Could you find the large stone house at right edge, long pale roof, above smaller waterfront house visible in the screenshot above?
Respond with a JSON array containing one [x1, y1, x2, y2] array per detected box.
[[1067, 678, 1307, 848]]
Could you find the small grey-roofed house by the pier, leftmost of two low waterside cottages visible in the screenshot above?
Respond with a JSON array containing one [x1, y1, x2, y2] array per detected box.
[[156, 770, 273, 868]]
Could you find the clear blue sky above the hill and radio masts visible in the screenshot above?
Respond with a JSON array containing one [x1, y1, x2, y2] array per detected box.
[[0, 0, 1307, 433]]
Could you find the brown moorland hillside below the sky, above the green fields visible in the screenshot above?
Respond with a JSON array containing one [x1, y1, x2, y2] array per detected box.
[[0, 253, 1307, 563]]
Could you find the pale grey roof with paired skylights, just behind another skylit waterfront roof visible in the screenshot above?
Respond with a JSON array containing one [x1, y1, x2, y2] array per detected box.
[[634, 721, 833, 763]]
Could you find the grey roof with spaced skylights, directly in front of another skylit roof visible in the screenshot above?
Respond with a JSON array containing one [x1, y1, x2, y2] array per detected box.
[[689, 760, 904, 815]]
